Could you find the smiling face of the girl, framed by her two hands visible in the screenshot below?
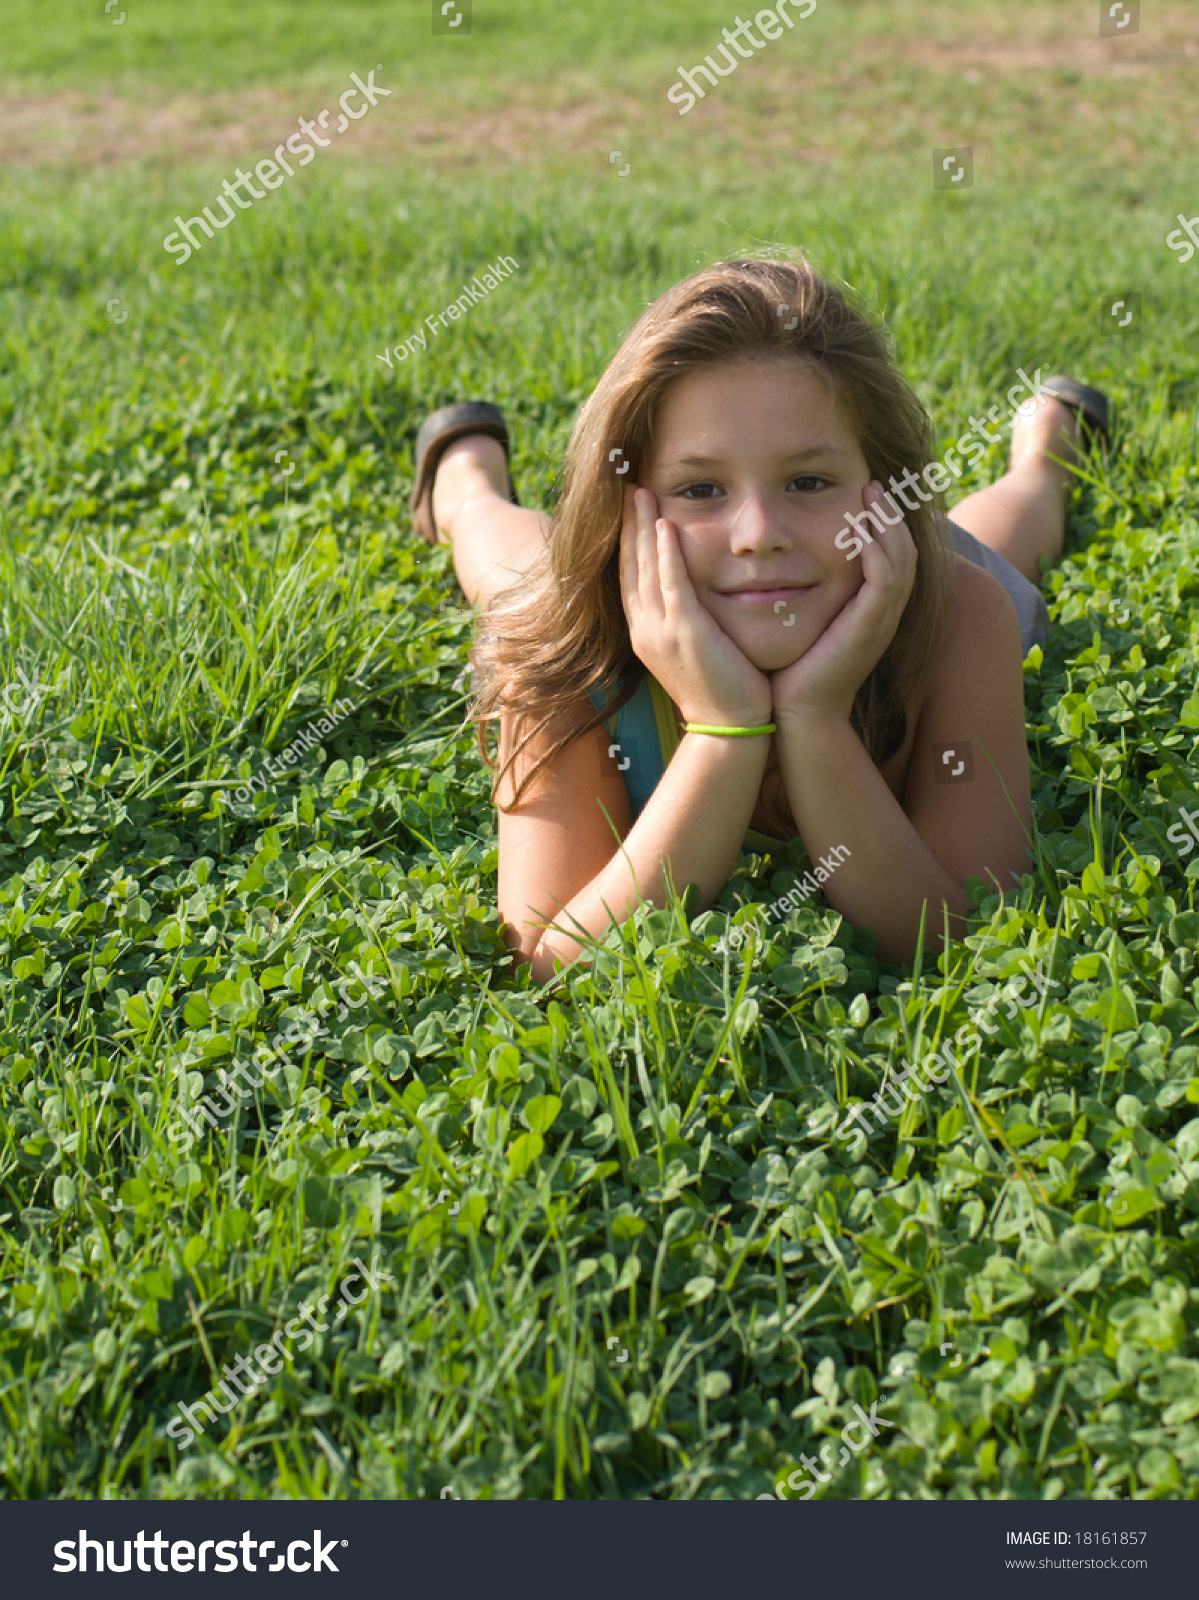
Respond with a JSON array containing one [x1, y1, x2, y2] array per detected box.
[[642, 357, 871, 672]]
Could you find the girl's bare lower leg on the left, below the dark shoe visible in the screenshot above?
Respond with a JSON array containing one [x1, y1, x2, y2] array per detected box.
[[432, 434, 549, 605]]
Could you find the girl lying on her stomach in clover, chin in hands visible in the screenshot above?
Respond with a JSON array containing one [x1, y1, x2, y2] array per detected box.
[[413, 259, 1106, 981]]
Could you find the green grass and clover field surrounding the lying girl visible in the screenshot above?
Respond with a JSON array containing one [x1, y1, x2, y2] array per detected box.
[[0, 0, 1199, 1499]]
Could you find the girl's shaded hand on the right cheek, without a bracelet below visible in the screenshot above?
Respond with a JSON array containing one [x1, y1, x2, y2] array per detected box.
[[770, 480, 917, 728]]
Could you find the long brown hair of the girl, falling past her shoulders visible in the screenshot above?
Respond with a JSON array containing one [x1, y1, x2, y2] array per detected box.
[[471, 258, 952, 805]]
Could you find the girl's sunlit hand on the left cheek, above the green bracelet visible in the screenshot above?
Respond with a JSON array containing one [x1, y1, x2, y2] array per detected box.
[[621, 485, 770, 728]]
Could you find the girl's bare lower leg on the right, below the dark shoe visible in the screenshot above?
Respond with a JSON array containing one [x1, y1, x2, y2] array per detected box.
[[947, 395, 1079, 584]]
